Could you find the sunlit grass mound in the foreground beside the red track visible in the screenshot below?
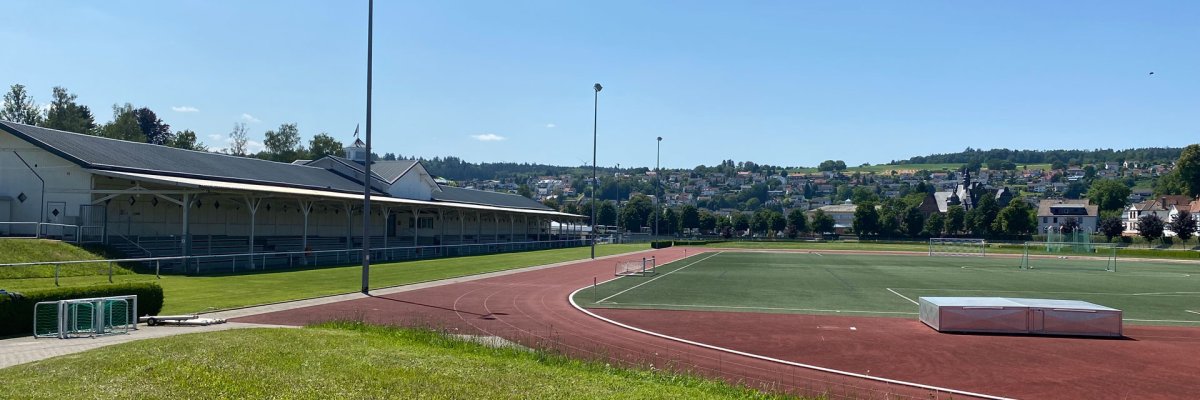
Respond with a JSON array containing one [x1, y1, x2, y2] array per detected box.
[[0, 323, 787, 399]]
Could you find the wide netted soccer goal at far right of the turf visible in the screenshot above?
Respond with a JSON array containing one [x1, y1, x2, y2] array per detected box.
[[1021, 241, 1117, 271]]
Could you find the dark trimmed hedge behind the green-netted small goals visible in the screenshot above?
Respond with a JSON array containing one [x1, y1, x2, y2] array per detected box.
[[0, 282, 163, 336]]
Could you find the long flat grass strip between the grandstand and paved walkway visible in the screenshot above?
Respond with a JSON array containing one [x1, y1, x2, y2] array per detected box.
[[0, 241, 649, 314]]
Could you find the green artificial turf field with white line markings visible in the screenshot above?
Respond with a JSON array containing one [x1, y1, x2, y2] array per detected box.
[[575, 251, 1200, 327]]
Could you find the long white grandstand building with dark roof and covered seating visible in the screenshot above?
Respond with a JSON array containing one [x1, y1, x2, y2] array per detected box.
[[0, 121, 583, 266]]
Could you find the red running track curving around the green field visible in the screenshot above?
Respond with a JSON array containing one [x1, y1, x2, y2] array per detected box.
[[236, 247, 1200, 399]]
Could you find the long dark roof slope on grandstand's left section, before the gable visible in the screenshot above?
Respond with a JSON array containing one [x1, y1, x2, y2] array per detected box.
[[0, 121, 374, 192]]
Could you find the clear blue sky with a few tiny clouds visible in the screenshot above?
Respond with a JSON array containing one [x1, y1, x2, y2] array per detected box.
[[0, 0, 1200, 167]]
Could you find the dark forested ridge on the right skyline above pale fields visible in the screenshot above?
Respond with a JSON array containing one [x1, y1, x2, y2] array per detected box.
[[889, 148, 1183, 165]]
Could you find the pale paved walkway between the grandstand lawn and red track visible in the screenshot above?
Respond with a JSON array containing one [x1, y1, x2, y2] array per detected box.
[[0, 250, 650, 369]]
